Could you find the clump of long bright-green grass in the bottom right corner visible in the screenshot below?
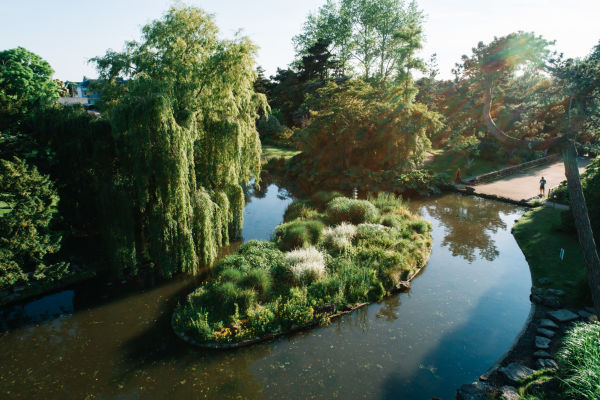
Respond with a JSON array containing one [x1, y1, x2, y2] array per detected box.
[[557, 322, 600, 400]]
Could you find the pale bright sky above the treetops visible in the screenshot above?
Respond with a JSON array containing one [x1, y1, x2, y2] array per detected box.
[[0, 0, 600, 80]]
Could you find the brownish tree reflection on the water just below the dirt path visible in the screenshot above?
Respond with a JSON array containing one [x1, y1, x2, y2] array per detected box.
[[425, 196, 515, 263]]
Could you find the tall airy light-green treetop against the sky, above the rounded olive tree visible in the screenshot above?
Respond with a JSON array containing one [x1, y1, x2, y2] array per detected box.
[[294, 0, 424, 81]]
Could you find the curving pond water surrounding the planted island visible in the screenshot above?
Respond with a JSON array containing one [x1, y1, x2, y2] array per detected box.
[[0, 185, 531, 400]]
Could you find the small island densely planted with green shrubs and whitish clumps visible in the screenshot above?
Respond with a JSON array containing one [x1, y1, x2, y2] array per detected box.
[[172, 192, 432, 348]]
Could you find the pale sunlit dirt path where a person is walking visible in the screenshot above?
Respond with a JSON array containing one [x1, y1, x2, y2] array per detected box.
[[474, 158, 590, 201]]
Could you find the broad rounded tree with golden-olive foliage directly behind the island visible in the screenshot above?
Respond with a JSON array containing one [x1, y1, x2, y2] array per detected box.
[[292, 80, 441, 191]]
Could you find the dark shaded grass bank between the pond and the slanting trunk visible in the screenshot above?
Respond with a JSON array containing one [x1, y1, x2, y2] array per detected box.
[[513, 207, 590, 307]]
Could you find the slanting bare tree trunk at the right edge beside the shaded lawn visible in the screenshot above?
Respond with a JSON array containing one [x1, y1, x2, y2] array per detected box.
[[561, 141, 600, 315]]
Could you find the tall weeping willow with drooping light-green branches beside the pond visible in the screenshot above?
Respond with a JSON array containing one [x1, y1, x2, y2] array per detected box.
[[92, 7, 267, 276]]
